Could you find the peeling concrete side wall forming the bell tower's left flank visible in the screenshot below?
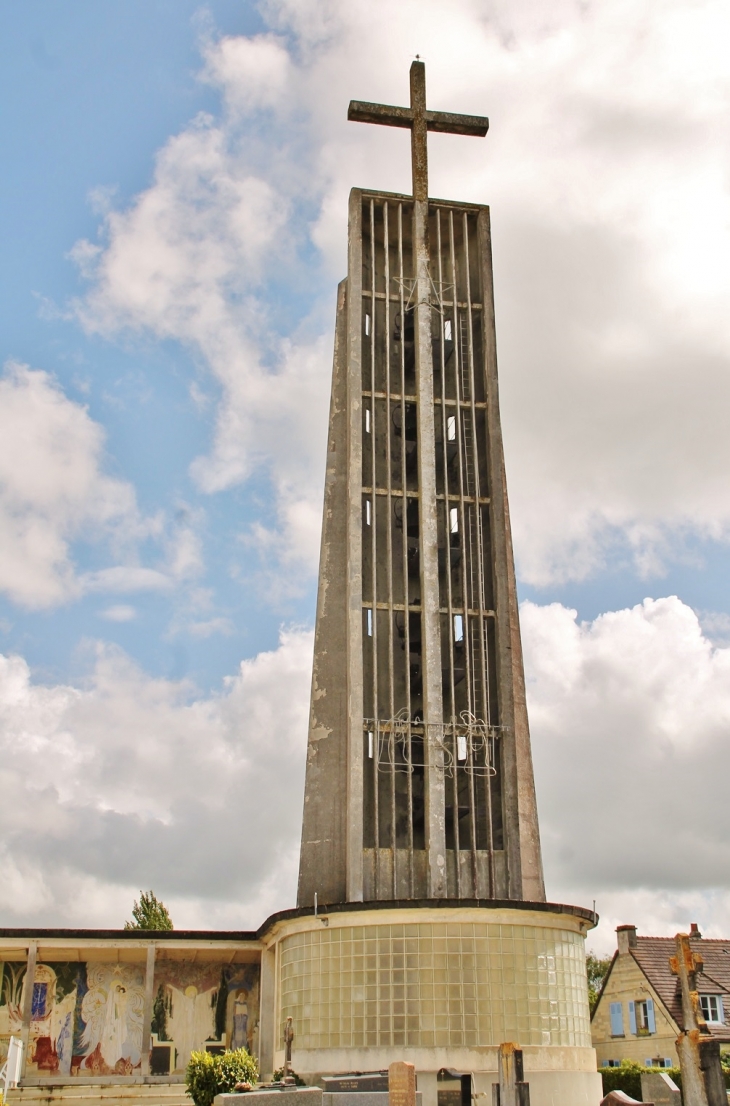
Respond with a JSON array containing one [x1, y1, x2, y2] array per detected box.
[[296, 280, 348, 907]]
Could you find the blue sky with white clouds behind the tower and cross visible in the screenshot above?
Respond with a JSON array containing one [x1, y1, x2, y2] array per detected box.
[[0, 0, 730, 951]]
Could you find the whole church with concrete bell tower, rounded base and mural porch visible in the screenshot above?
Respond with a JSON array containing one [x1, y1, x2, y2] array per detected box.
[[0, 61, 602, 1106]]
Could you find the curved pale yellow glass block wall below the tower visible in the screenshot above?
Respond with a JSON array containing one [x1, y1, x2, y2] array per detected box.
[[280, 922, 591, 1048]]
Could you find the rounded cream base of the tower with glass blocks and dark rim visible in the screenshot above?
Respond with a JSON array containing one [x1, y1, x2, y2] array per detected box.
[[261, 901, 602, 1106]]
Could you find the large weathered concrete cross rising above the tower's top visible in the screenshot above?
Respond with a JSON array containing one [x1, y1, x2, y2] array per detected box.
[[347, 61, 489, 201]]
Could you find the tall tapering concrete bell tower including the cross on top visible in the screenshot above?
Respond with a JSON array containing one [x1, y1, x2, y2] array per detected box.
[[298, 60, 545, 907]]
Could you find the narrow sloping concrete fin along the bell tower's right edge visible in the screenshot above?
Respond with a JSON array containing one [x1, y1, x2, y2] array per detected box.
[[479, 208, 545, 901]]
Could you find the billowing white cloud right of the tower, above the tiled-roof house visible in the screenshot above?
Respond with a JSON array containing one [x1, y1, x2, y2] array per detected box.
[[522, 597, 730, 940]]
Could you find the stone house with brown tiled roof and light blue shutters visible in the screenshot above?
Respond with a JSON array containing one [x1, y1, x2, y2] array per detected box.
[[591, 925, 730, 1067]]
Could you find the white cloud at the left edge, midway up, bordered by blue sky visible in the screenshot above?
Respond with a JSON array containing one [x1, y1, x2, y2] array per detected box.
[[0, 363, 213, 617]]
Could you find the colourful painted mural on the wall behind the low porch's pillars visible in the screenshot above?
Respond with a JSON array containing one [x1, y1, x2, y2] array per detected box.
[[0, 960, 259, 1077]]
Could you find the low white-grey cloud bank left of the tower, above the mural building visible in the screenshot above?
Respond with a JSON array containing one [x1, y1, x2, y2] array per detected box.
[[0, 630, 312, 928]]
